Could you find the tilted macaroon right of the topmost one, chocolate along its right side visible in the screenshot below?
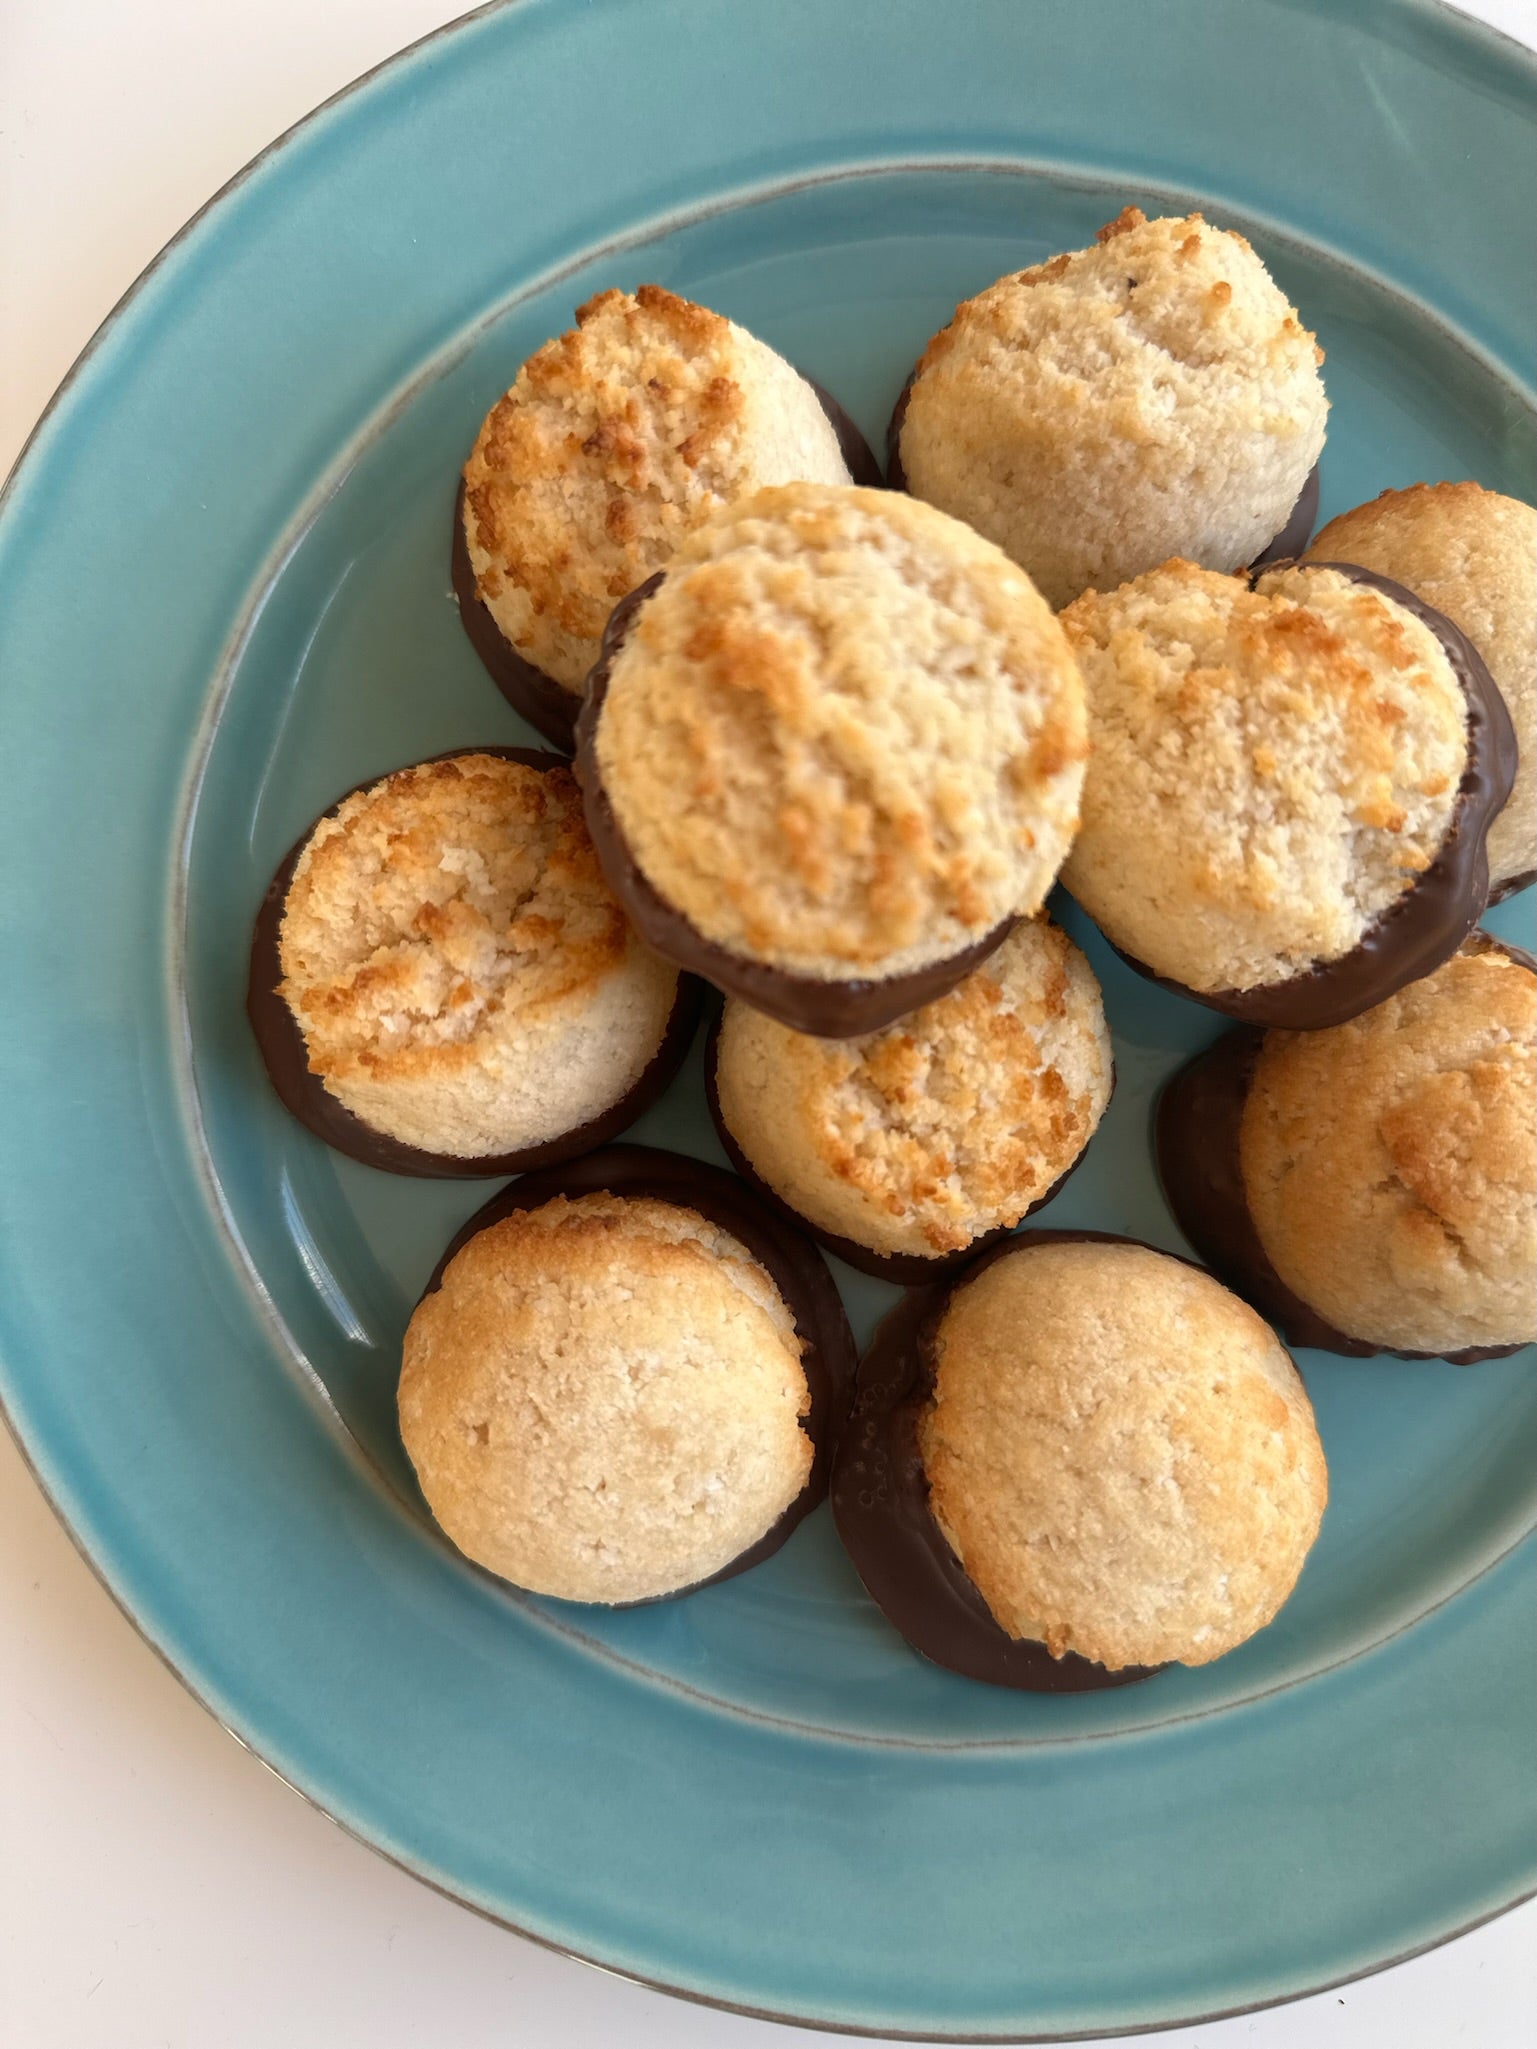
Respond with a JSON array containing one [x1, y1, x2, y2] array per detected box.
[[1062, 561, 1514, 1029]]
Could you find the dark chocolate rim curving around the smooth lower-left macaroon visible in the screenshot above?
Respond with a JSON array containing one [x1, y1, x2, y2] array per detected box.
[[422, 1145, 857, 1608]]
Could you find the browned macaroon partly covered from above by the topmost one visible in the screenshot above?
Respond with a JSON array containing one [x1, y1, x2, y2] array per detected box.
[[711, 916, 1115, 1279]]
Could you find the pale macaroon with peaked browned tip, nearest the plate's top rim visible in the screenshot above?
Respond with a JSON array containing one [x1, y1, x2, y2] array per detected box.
[[891, 207, 1328, 607]]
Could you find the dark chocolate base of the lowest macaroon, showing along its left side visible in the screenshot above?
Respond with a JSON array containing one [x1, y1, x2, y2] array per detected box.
[[832, 1231, 1164, 1692]]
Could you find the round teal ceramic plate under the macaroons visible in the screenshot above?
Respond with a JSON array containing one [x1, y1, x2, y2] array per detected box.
[[0, 0, 1537, 2039]]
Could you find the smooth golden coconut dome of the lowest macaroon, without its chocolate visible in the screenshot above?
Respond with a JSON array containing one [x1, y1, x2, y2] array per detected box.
[[918, 1236, 1328, 1666]]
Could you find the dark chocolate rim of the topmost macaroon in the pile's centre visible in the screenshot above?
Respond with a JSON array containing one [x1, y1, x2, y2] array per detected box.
[[576, 570, 1019, 1039]]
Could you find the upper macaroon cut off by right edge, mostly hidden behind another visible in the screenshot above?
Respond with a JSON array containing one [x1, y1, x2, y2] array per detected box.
[[1310, 484, 1537, 900]]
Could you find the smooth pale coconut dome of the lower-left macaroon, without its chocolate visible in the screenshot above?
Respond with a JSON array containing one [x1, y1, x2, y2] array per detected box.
[[400, 1193, 812, 1604]]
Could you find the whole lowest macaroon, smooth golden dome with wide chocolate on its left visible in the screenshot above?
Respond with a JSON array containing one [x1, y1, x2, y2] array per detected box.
[[832, 1231, 1328, 1692]]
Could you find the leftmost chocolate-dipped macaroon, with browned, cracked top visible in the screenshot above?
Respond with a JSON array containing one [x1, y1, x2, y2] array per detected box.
[[248, 748, 697, 1176]]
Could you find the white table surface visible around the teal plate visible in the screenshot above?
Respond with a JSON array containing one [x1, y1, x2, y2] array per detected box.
[[0, 0, 1537, 2049]]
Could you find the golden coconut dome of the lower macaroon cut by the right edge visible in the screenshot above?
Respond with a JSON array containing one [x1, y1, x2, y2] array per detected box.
[[1240, 934, 1537, 1352]]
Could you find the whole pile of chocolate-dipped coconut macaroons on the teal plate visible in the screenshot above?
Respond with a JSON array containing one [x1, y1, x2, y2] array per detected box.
[[250, 228, 1537, 1692]]
